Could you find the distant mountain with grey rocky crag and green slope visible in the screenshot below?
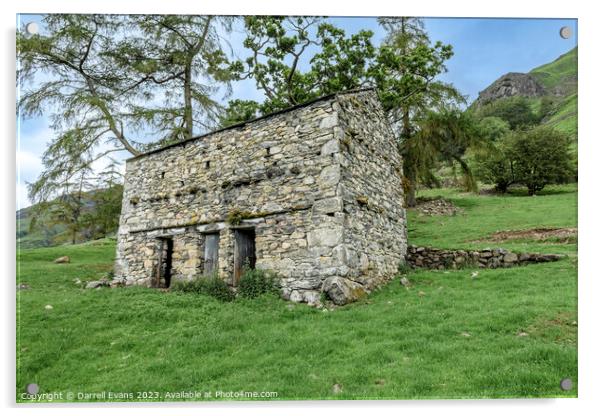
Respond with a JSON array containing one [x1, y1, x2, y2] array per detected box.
[[471, 48, 577, 139]]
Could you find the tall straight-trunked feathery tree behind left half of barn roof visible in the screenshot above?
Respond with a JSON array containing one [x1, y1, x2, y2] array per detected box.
[[118, 15, 233, 144]]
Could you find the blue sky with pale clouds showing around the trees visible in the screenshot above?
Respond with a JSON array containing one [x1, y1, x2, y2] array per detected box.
[[16, 16, 577, 208]]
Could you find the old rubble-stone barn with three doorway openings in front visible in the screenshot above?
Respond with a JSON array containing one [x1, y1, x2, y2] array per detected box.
[[115, 89, 406, 304]]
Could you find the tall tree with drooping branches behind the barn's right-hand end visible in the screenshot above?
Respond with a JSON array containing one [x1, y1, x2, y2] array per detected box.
[[371, 17, 465, 207]]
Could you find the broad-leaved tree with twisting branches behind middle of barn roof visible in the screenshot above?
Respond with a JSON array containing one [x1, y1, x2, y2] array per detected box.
[[232, 16, 375, 114]]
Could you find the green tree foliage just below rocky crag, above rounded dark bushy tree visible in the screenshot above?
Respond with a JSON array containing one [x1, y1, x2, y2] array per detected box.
[[477, 96, 540, 130]]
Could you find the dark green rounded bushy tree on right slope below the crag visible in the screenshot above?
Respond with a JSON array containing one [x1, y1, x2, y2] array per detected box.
[[474, 126, 575, 195]]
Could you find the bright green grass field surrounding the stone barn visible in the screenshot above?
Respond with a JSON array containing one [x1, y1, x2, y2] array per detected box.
[[17, 185, 577, 402]]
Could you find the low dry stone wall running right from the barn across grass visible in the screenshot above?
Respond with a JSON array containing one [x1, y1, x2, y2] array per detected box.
[[406, 245, 563, 269]]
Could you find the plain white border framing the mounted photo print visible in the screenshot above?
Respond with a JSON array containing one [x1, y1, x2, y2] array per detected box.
[[0, 0, 602, 416]]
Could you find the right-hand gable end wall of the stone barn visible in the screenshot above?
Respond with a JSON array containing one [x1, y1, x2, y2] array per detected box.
[[335, 95, 407, 288]]
